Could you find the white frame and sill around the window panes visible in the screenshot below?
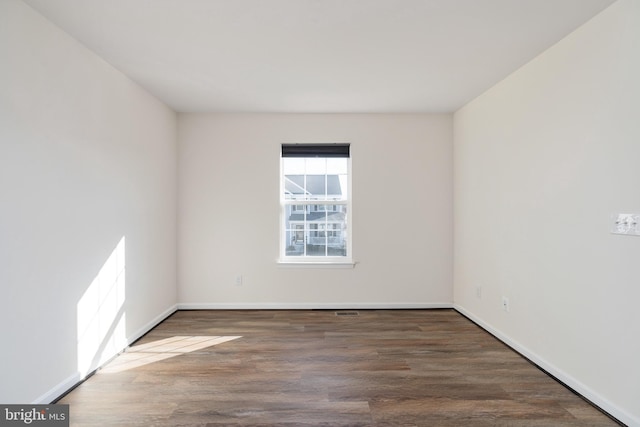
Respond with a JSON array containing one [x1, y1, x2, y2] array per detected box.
[[278, 146, 355, 268]]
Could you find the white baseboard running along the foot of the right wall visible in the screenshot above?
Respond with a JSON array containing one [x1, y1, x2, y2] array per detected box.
[[453, 304, 640, 427]]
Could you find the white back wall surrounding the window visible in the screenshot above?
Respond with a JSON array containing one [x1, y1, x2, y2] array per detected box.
[[178, 114, 453, 308]]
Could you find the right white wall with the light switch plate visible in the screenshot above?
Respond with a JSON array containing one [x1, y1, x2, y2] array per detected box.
[[454, 0, 640, 425]]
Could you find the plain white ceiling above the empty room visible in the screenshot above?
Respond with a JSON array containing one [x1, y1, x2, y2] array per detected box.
[[24, 0, 613, 112]]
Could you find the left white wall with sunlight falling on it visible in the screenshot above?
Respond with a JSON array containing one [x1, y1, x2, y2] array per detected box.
[[0, 0, 177, 403]]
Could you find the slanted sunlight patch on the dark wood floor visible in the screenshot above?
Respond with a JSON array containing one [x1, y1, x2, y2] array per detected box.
[[99, 336, 242, 374]]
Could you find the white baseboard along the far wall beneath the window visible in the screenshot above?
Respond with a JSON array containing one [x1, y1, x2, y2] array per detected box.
[[178, 302, 453, 310]]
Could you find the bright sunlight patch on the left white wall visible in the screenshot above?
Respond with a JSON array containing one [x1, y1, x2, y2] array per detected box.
[[77, 236, 128, 378]]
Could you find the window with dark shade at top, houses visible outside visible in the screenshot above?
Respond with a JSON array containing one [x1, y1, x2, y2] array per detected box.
[[280, 144, 351, 263]]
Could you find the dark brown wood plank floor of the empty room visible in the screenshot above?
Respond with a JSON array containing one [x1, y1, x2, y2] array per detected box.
[[59, 310, 618, 427]]
